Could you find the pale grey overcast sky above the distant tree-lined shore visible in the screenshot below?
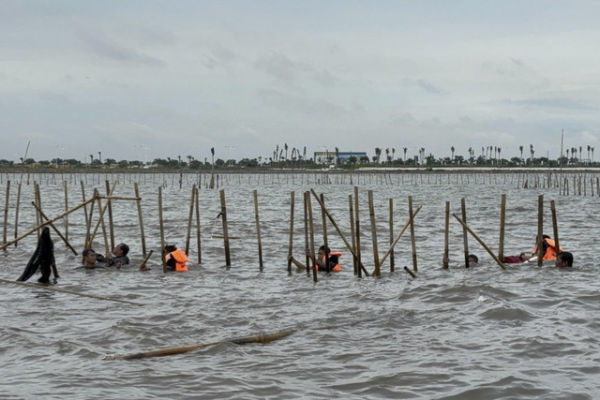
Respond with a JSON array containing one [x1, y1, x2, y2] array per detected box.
[[0, 0, 600, 160]]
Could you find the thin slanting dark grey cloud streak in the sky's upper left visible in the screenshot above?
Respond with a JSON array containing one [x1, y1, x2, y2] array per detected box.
[[78, 31, 166, 67]]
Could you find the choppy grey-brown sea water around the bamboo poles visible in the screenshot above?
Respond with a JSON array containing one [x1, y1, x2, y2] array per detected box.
[[0, 173, 600, 399]]
